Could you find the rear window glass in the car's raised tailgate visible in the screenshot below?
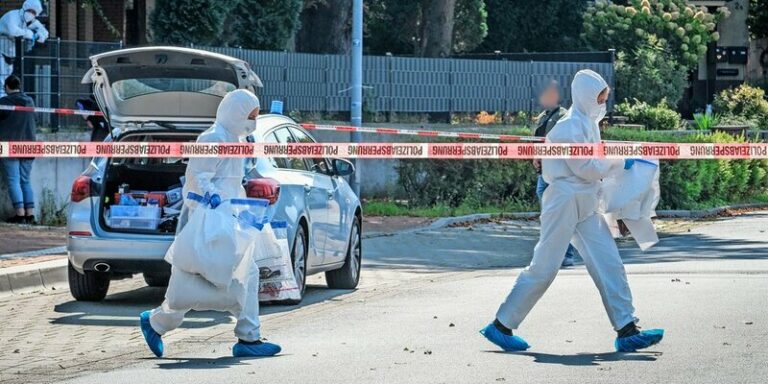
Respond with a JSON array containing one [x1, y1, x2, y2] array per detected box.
[[112, 78, 237, 100]]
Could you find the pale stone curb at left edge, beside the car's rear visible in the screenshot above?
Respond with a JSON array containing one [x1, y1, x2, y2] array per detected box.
[[0, 259, 68, 296]]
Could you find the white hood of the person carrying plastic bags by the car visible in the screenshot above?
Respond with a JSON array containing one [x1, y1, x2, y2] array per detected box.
[[216, 89, 260, 139]]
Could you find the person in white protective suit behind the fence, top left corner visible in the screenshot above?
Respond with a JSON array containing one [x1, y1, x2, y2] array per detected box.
[[0, 0, 48, 96]]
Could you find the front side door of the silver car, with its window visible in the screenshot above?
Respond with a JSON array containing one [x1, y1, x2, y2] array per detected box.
[[291, 127, 346, 264]]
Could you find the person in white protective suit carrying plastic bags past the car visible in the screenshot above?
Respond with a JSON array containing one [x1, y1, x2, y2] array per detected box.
[[140, 89, 280, 357]]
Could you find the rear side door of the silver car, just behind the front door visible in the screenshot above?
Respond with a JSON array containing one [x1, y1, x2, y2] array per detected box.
[[271, 126, 328, 265]]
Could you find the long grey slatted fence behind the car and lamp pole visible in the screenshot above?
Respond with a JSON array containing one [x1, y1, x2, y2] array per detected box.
[[201, 47, 614, 113]]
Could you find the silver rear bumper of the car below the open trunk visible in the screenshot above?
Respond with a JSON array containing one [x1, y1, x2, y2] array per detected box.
[[67, 236, 172, 273]]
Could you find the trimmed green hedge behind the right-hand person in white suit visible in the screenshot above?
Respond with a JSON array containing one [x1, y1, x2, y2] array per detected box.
[[397, 128, 768, 209]]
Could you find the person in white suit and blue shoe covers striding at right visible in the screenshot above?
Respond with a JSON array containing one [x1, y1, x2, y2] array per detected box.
[[480, 70, 664, 352]]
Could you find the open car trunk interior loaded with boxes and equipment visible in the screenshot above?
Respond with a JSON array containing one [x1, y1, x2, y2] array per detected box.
[[99, 130, 200, 235]]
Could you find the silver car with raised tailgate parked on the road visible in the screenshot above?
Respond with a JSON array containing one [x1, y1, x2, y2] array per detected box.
[[67, 47, 362, 303]]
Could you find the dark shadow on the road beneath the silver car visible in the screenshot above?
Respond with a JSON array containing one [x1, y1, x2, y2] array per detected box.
[[50, 285, 354, 329]]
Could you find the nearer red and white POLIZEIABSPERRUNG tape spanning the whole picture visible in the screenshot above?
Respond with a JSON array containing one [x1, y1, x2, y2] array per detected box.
[[0, 142, 768, 159]]
